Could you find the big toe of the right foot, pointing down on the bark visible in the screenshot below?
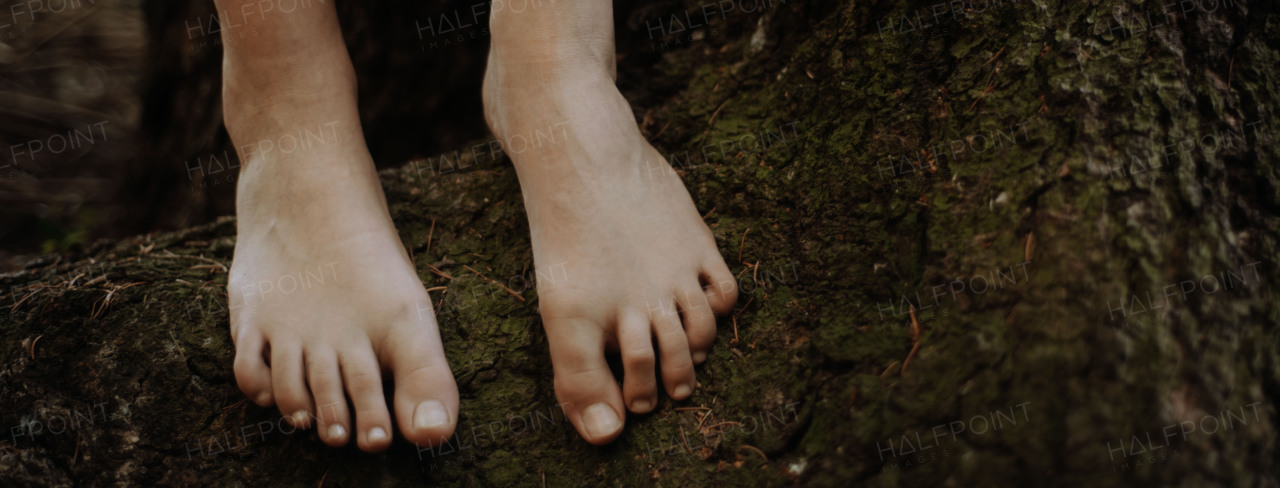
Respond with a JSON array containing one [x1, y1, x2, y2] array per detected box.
[[547, 319, 625, 446]]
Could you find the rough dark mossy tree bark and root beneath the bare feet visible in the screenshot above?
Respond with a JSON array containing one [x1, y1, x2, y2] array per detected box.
[[0, 0, 1280, 487]]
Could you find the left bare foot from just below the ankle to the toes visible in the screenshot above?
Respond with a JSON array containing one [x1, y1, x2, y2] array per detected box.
[[228, 129, 458, 451]]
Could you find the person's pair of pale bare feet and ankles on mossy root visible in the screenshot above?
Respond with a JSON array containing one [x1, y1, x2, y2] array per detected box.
[[216, 0, 737, 452]]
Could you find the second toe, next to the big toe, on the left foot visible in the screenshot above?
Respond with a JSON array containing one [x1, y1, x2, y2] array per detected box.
[[338, 342, 392, 452]]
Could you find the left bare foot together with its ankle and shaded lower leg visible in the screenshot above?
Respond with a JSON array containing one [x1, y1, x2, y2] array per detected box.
[[219, 0, 458, 451]]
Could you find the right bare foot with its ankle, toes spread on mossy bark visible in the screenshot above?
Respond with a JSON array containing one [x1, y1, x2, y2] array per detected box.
[[484, 3, 737, 444]]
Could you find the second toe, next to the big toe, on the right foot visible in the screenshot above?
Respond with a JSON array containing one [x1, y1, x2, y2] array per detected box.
[[618, 314, 658, 414]]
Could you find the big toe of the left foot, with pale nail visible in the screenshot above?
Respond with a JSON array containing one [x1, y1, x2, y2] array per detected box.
[[387, 313, 458, 447]]
